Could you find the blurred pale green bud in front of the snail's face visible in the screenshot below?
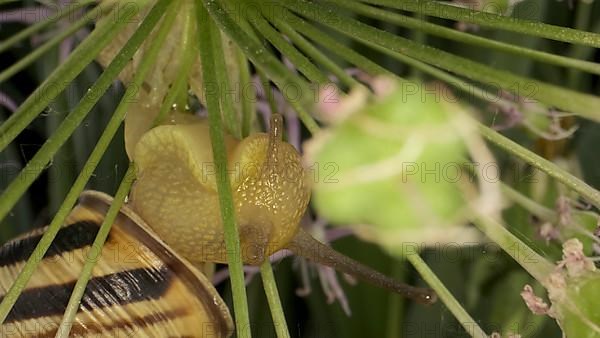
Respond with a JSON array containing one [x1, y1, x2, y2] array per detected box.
[[305, 78, 486, 248]]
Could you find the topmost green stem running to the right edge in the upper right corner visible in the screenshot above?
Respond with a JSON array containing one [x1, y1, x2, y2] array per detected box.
[[362, 0, 600, 48]]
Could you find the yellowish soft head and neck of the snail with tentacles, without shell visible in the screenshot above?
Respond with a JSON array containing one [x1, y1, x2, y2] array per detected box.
[[130, 114, 436, 304]]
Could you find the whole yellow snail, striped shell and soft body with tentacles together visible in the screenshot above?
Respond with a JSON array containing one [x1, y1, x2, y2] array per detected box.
[[0, 115, 436, 337]]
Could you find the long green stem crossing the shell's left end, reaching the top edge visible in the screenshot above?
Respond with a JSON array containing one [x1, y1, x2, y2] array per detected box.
[[0, 0, 177, 324]]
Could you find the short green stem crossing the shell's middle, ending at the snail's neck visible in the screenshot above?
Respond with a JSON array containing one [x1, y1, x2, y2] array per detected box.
[[56, 163, 136, 338]]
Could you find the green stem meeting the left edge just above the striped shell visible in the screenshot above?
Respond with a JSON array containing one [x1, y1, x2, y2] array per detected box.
[[0, 0, 169, 226]]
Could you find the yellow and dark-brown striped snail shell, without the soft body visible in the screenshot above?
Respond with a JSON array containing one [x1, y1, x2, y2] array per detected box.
[[0, 191, 233, 337]]
